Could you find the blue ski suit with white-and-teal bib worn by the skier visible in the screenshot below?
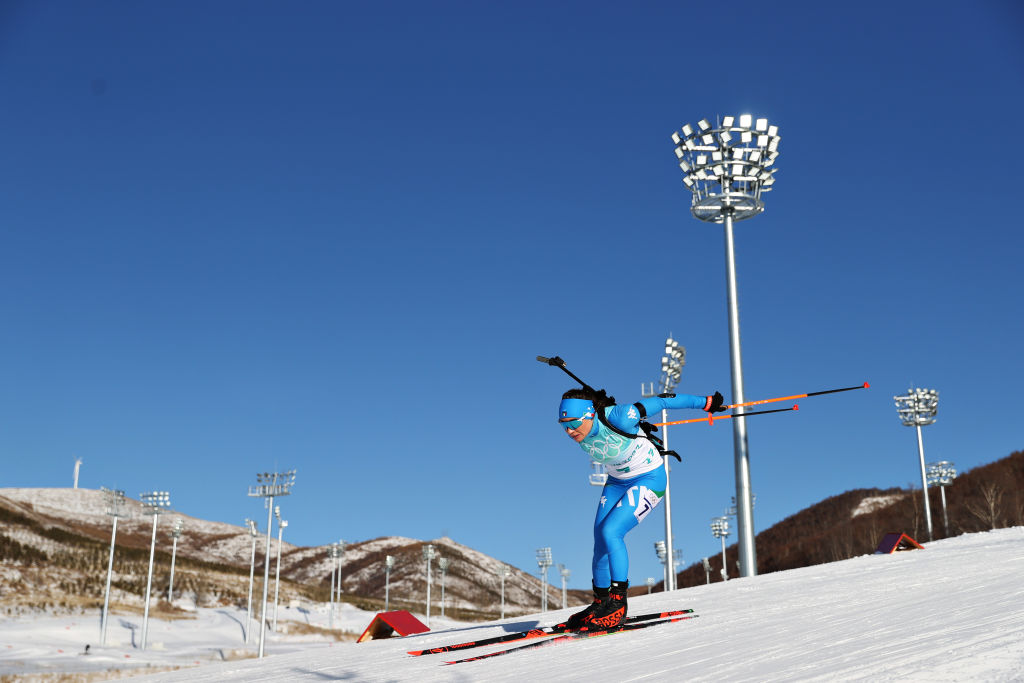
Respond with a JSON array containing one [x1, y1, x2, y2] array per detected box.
[[580, 394, 709, 587]]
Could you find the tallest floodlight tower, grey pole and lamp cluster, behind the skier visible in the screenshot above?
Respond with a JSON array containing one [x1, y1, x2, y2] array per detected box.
[[672, 114, 780, 577]]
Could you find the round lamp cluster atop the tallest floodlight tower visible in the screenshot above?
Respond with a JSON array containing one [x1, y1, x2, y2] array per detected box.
[[672, 114, 781, 222]]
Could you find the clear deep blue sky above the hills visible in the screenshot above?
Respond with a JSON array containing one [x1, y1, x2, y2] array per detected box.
[[0, 0, 1024, 587]]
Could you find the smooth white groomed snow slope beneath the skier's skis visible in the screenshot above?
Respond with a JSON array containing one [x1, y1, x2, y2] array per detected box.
[[114, 527, 1024, 683]]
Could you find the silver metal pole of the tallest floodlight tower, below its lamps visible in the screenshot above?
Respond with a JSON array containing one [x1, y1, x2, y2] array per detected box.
[[722, 208, 758, 577]]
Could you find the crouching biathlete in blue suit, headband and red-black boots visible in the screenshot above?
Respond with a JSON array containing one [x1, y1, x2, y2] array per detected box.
[[558, 389, 726, 629]]
